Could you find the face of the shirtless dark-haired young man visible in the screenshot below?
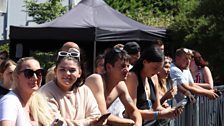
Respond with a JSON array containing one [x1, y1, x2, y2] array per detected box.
[[110, 60, 129, 81]]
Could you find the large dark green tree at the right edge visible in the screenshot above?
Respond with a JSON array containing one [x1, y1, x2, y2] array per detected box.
[[168, 0, 224, 83]]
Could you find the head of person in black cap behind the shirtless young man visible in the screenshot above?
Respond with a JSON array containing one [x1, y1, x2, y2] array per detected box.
[[123, 42, 141, 70]]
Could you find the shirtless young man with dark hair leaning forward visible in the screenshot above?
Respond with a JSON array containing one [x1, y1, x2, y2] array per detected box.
[[86, 49, 142, 126]]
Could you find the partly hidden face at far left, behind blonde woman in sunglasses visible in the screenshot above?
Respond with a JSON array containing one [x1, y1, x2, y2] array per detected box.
[[3, 64, 16, 89]]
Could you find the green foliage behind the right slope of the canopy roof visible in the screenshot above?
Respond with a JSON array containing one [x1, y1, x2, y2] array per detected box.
[[105, 0, 177, 28]]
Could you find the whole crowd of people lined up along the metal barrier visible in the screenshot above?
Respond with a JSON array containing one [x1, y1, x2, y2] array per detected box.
[[0, 40, 219, 126]]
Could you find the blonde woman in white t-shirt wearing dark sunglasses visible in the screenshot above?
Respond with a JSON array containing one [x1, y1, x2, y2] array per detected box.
[[0, 57, 53, 126]]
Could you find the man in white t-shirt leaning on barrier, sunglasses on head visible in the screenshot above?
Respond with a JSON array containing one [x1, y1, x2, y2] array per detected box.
[[170, 48, 218, 102]]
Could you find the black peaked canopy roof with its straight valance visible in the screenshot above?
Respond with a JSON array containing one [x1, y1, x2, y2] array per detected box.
[[10, 0, 166, 42]]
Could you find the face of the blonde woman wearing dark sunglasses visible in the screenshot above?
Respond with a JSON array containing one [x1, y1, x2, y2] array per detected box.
[[17, 59, 42, 93]]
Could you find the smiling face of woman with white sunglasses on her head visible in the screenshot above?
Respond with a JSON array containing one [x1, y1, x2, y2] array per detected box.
[[55, 59, 81, 91]]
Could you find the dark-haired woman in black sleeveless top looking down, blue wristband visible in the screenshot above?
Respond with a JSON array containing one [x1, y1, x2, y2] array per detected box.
[[126, 45, 183, 126]]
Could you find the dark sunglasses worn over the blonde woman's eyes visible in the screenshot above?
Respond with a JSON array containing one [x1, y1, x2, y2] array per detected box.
[[20, 69, 44, 79]]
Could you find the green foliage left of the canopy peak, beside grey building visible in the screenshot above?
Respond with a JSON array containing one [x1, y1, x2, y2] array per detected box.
[[25, 0, 67, 24]]
